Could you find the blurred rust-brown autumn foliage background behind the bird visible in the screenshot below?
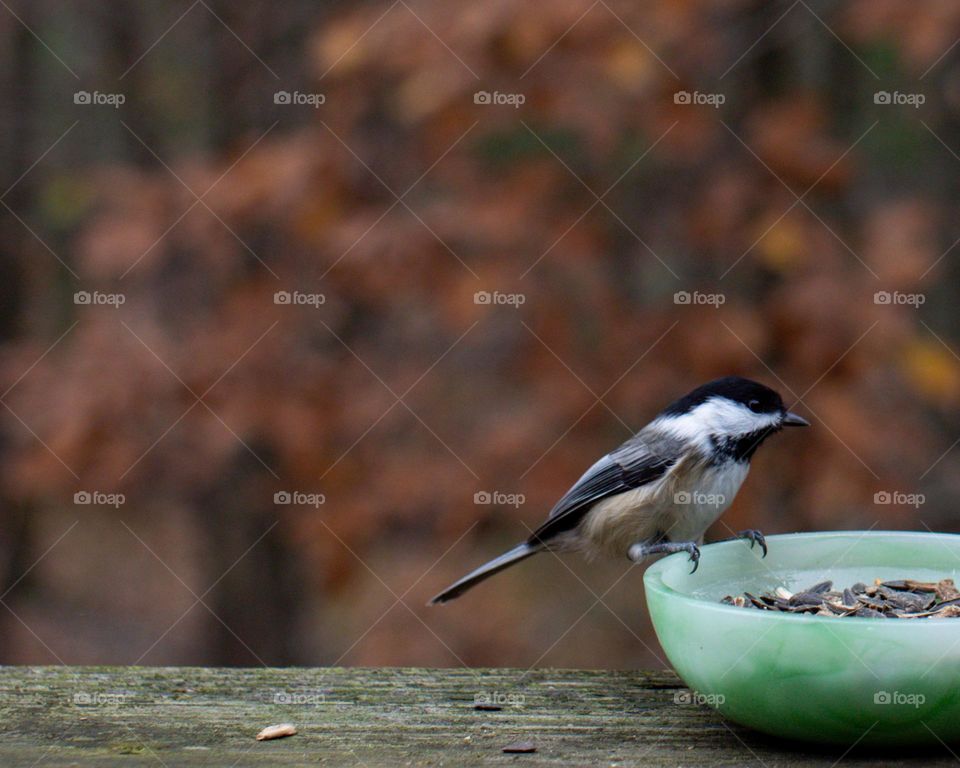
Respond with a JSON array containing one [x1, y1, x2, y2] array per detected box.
[[0, 0, 960, 667]]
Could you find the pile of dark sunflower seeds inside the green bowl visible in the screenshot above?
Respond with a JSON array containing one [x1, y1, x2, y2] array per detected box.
[[720, 579, 960, 619]]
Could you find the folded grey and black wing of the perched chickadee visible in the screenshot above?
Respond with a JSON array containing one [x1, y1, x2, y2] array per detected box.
[[527, 431, 683, 544]]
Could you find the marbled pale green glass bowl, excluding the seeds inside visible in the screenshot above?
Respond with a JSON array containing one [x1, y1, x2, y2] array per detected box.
[[644, 531, 960, 745]]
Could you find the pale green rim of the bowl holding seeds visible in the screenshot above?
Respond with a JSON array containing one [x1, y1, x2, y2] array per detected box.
[[643, 530, 960, 631]]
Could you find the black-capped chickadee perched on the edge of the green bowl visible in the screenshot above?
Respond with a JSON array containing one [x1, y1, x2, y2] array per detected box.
[[430, 376, 809, 604]]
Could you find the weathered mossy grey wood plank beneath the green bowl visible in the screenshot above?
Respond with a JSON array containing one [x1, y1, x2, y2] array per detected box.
[[0, 667, 956, 768]]
